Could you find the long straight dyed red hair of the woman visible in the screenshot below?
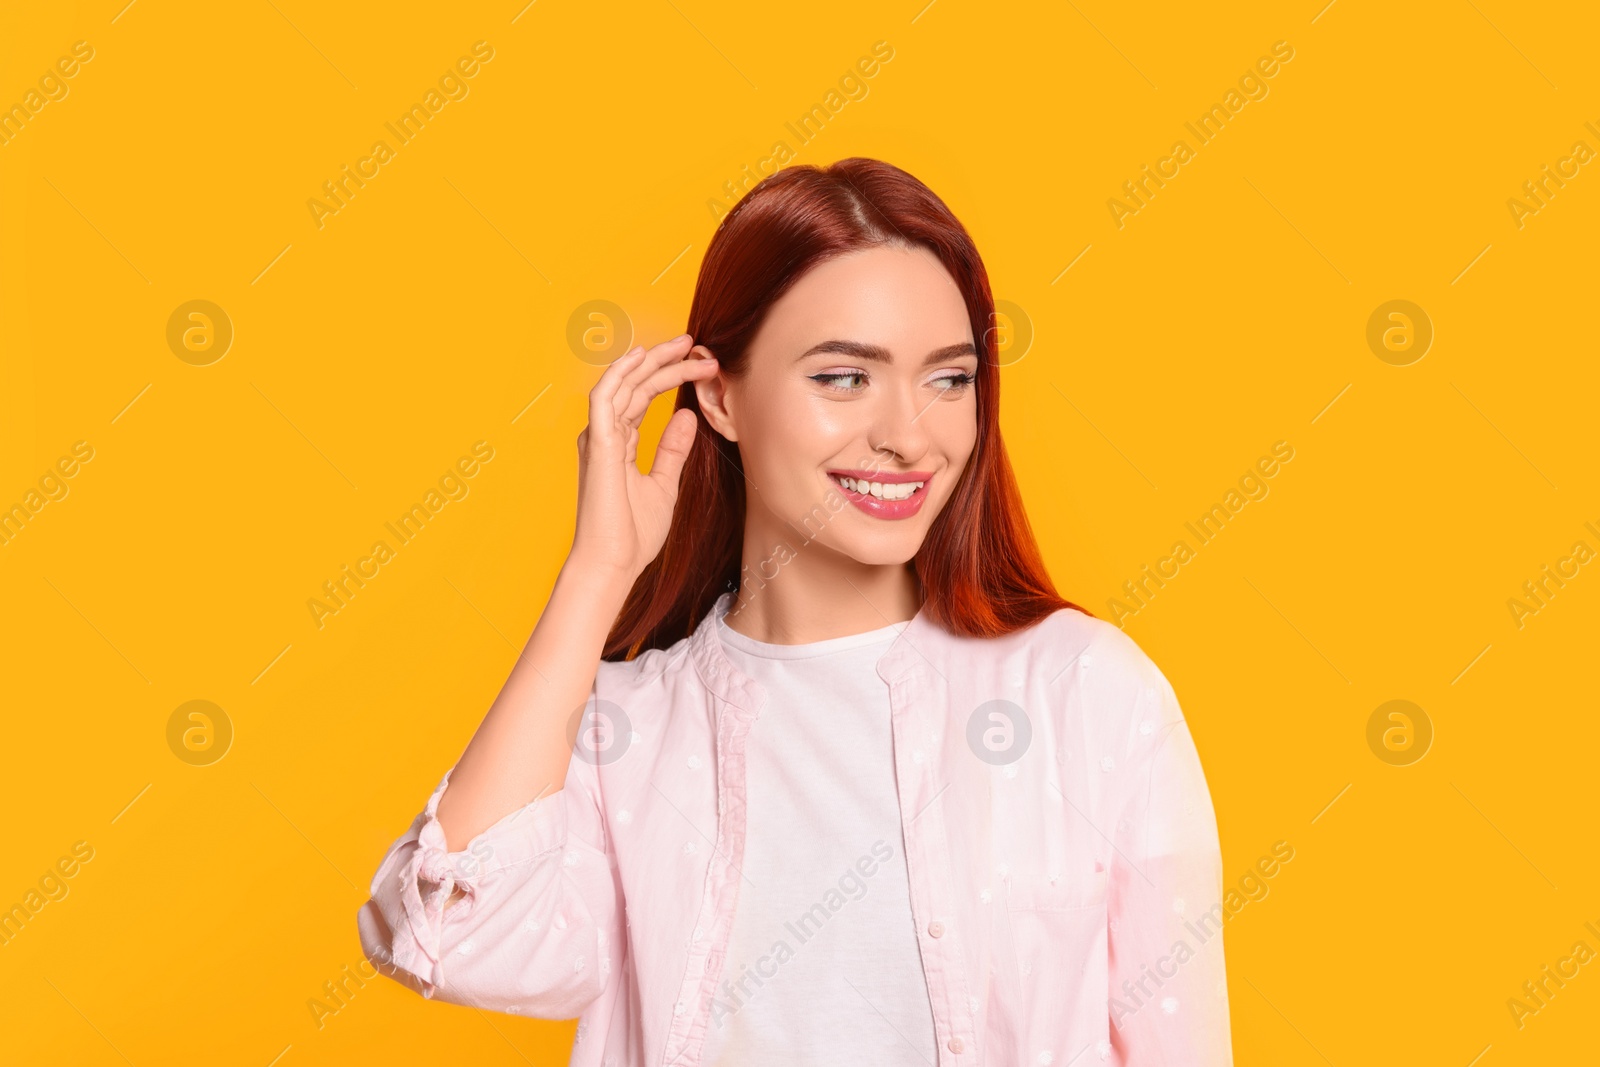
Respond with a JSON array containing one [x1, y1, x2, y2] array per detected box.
[[603, 158, 1093, 661]]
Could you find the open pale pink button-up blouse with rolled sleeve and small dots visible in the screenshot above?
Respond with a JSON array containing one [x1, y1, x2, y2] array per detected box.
[[358, 593, 1232, 1067]]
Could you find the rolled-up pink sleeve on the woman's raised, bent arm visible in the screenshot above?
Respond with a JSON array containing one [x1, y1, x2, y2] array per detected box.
[[357, 758, 622, 1019]]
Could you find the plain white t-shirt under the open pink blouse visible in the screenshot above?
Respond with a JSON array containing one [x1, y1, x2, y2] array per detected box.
[[701, 604, 939, 1067]]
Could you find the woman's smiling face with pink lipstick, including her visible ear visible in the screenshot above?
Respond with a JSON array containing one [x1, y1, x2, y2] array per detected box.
[[696, 245, 978, 565]]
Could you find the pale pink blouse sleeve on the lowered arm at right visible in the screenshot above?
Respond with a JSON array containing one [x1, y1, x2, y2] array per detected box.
[[1107, 664, 1234, 1067]]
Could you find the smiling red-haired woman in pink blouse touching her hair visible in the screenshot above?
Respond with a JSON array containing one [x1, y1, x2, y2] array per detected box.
[[360, 158, 1230, 1067]]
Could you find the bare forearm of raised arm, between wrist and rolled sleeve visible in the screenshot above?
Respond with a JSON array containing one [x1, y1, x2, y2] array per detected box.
[[438, 557, 632, 851]]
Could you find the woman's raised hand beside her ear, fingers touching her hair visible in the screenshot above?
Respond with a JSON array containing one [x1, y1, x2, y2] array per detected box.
[[573, 334, 718, 579]]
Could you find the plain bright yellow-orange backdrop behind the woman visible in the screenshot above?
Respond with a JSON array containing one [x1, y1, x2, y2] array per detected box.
[[0, 0, 1600, 1067]]
